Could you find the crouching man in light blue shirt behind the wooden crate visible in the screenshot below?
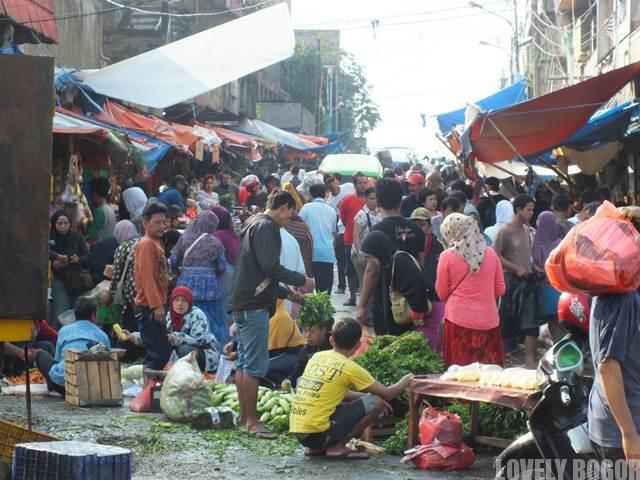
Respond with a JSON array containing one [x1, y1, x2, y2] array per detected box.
[[35, 298, 111, 395]]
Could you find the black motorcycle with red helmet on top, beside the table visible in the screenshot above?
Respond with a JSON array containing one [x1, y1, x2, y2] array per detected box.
[[495, 294, 600, 480]]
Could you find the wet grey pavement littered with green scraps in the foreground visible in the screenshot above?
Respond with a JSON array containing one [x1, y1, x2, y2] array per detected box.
[[0, 396, 494, 480]]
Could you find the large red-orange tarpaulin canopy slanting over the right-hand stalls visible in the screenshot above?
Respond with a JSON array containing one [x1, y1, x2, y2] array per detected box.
[[465, 62, 640, 163]]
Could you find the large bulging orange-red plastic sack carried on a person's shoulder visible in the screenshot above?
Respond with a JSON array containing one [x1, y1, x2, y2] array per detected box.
[[545, 202, 640, 296]]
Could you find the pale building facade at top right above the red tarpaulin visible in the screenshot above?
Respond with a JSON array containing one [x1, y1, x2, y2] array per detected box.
[[524, 0, 640, 103]]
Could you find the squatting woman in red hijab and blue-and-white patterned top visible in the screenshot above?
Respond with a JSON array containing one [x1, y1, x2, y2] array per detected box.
[[167, 287, 220, 372]]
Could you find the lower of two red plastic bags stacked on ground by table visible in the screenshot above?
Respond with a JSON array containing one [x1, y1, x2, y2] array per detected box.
[[402, 443, 476, 470]]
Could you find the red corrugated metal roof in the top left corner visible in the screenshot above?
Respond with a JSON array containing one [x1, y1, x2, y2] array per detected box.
[[0, 0, 58, 44]]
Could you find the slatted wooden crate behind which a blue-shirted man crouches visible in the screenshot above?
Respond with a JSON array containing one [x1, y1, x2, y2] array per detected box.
[[64, 349, 122, 407]]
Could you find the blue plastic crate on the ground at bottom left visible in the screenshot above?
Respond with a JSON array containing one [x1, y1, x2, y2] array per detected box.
[[13, 441, 132, 480]]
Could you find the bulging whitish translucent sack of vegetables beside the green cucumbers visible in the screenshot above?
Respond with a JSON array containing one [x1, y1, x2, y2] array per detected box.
[[160, 352, 213, 422]]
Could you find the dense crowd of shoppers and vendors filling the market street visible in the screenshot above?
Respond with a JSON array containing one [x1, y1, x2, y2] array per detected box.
[[5, 161, 608, 456]]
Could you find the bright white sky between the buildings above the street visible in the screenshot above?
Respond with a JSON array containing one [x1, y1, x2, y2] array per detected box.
[[292, 0, 513, 156]]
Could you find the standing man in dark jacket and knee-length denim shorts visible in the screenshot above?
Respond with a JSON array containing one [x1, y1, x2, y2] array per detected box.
[[229, 189, 315, 439]]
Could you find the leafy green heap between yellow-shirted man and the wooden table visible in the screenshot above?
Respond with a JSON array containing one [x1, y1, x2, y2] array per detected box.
[[355, 332, 443, 385]]
